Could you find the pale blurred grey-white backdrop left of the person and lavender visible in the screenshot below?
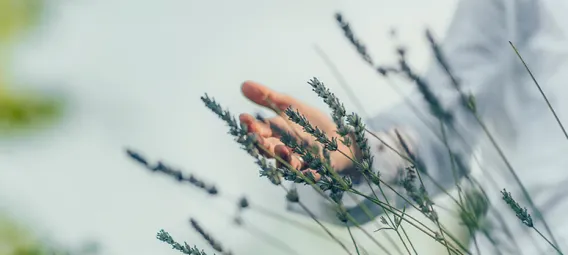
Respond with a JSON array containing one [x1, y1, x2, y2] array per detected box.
[[0, 0, 457, 255]]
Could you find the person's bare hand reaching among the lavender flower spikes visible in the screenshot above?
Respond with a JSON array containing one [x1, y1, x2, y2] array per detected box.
[[239, 81, 356, 178]]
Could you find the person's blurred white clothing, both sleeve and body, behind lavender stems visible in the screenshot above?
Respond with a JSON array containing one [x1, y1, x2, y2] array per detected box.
[[290, 0, 568, 254]]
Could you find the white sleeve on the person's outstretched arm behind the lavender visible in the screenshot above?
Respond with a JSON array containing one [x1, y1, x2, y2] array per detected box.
[[289, 0, 535, 223]]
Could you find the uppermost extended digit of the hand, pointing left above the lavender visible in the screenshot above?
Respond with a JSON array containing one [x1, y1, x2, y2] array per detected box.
[[241, 81, 300, 113]]
